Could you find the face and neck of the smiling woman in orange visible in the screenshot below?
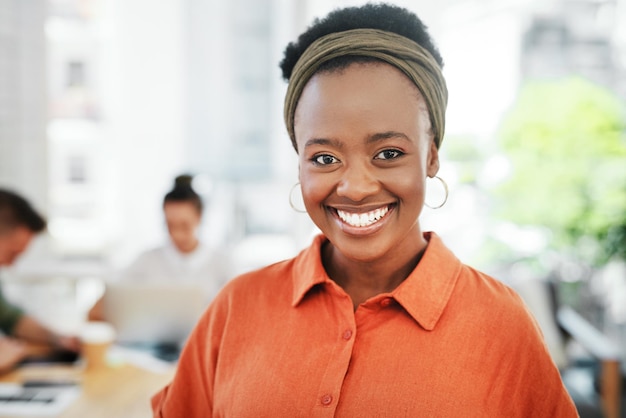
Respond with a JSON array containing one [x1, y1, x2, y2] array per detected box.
[[295, 62, 439, 278]]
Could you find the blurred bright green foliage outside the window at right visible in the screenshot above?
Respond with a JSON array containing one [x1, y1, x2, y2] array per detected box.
[[495, 78, 626, 265]]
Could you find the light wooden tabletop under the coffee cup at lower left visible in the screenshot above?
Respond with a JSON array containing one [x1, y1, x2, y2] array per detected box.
[[0, 348, 175, 418]]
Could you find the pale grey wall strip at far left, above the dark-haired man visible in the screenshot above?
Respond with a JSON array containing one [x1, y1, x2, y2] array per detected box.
[[0, 0, 47, 211]]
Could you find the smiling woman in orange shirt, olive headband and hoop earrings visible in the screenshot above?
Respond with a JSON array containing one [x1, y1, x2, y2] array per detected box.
[[152, 4, 577, 418]]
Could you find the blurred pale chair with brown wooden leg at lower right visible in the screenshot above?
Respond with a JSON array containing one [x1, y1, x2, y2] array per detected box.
[[509, 279, 623, 418]]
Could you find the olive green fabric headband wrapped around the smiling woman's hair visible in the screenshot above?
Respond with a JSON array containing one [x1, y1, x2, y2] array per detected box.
[[284, 29, 448, 151]]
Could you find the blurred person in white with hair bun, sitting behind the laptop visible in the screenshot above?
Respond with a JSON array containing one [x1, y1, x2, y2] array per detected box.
[[89, 174, 231, 320]]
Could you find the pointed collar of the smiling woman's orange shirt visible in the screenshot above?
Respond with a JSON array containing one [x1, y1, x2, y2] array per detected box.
[[292, 232, 461, 331]]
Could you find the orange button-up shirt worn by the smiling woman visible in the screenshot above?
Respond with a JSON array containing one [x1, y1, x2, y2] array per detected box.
[[152, 233, 577, 418]]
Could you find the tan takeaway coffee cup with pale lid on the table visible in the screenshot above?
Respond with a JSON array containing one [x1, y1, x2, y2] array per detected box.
[[80, 321, 115, 370]]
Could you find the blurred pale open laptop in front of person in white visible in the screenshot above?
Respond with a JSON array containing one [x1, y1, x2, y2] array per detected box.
[[103, 283, 207, 356]]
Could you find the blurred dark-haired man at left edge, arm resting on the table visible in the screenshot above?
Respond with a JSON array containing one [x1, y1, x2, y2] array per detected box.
[[0, 189, 79, 373]]
